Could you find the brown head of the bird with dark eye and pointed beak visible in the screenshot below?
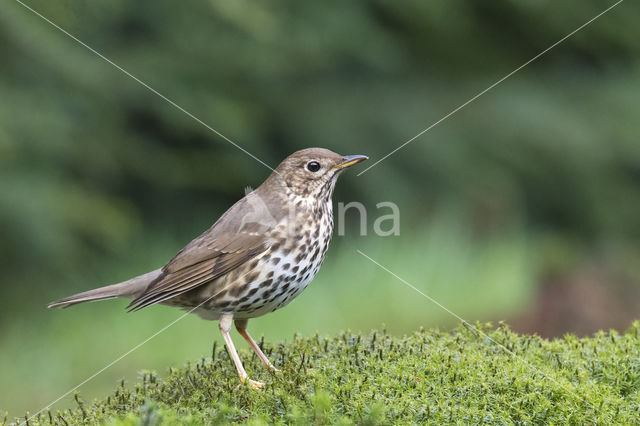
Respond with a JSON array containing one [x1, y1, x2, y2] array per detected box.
[[269, 148, 369, 200]]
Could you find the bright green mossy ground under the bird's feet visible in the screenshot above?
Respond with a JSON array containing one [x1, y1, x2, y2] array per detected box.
[[18, 322, 640, 425]]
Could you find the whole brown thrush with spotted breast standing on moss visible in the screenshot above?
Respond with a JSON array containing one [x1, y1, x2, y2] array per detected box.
[[48, 148, 368, 389]]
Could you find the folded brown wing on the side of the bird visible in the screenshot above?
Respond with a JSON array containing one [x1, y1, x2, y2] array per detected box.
[[128, 191, 272, 311]]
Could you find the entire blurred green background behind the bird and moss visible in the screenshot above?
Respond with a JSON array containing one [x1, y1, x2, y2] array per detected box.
[[0, 0, 640, 415]]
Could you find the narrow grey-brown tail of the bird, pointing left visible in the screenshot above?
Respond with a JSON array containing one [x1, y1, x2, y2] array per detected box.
[[47, 269, 162, 308]]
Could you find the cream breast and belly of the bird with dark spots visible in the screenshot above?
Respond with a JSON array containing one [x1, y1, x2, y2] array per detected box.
[[179, 178, 333, 319]]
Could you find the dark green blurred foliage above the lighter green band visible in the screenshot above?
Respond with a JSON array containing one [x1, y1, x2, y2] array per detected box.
[[0, 1, 640, 292]]
